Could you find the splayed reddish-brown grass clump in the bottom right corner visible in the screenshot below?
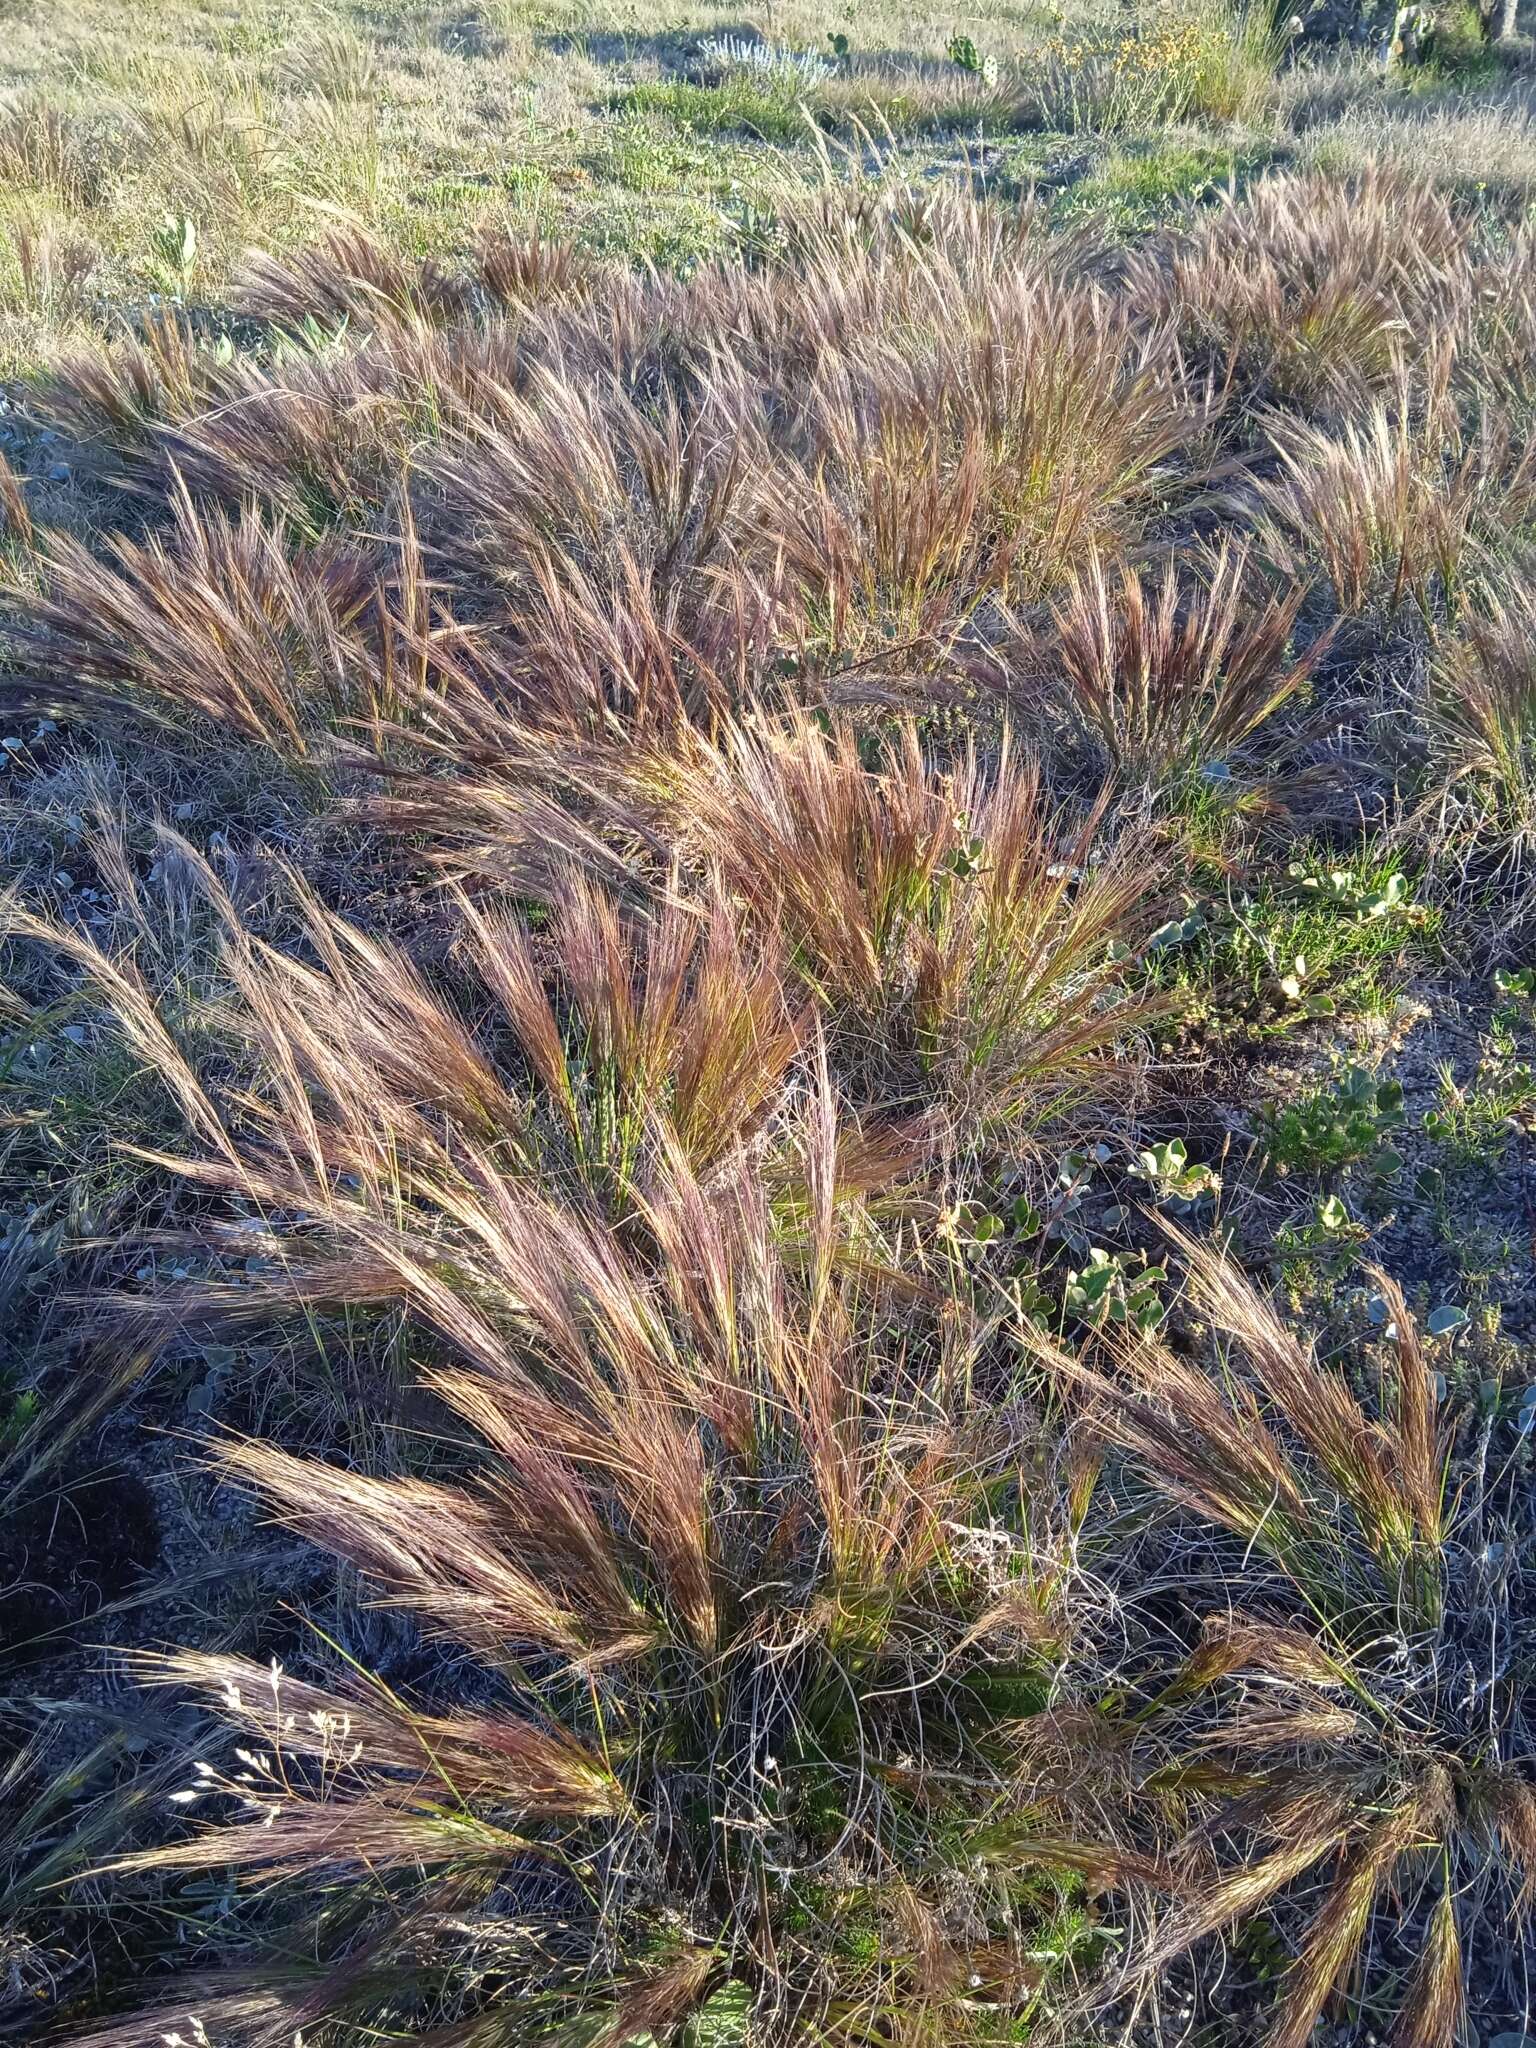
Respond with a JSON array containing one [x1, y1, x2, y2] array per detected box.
[[1024, 1243, 1536, 2048]]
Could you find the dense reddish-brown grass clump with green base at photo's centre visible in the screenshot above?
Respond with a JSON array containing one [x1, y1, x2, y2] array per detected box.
[[630, 721, 1147, 1130]]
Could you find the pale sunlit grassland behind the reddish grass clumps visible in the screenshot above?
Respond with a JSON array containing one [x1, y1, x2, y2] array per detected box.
[[0, 0, 1530, 373]]
